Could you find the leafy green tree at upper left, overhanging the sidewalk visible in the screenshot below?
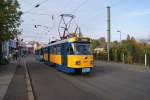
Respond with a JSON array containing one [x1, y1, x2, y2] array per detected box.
[[0, 0, 22, 63]]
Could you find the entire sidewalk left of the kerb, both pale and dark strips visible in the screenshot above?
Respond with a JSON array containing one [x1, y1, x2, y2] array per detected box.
[[0, 61, 28, 100]]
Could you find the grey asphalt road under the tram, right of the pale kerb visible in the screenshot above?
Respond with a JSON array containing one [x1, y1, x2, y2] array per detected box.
[[26, 57, 150, 100]]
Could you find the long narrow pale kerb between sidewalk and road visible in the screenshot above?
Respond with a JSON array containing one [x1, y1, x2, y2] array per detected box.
[[24, 60, 35, 100]]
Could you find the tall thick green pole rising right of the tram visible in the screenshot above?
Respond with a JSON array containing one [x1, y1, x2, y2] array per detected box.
[[107, 6, 111, 62]]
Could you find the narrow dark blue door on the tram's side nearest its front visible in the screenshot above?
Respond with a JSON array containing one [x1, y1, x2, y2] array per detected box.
[[62, 43, 68, 66]]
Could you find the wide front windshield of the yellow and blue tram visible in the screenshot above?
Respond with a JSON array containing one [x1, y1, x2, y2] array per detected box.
[[72, 43, 92, 55]]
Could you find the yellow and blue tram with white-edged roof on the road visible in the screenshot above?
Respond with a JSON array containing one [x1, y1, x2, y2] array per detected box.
[[35, 37, 93, 73]]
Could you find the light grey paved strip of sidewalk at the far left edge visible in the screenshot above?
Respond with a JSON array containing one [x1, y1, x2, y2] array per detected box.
[[0, 62, 16, 100]]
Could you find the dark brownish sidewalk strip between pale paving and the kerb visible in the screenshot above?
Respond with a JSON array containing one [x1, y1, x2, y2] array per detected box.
[[3, 63, 28, 100]]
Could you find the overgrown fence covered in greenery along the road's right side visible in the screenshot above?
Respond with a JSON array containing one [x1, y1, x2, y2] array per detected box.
[[93, 52, 150, 66]]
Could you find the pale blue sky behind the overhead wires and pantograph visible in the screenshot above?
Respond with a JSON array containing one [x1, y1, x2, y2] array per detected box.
[[19, 0, 150, 43]]
